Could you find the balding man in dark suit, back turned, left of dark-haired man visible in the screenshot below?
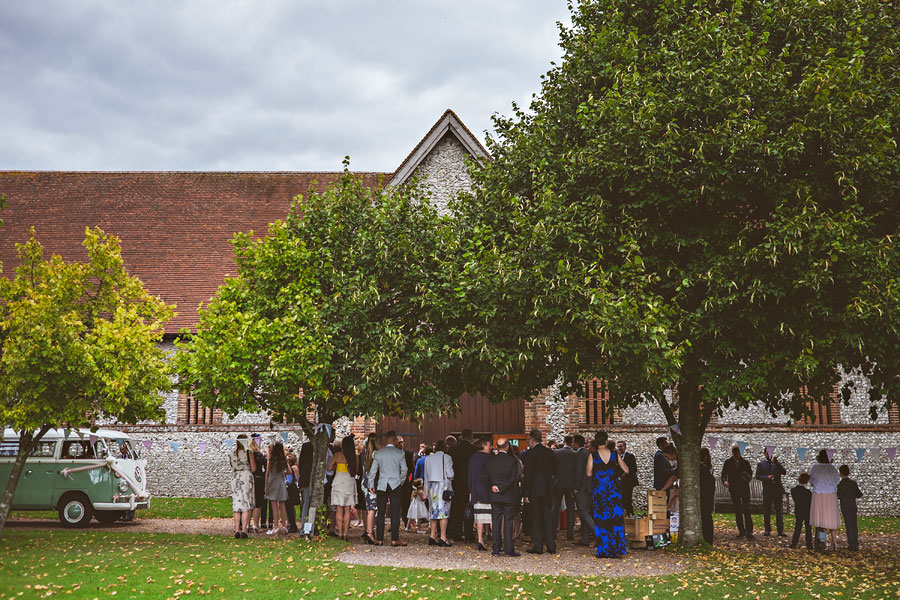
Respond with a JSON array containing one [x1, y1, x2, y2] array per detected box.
[[482, 438, 522, 556]]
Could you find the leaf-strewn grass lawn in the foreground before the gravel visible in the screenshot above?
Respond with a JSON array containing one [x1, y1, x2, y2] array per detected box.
[[0, 529, 900, 600]]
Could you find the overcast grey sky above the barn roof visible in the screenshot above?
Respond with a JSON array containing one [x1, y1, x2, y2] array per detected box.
[[0, 0, 568, 171]]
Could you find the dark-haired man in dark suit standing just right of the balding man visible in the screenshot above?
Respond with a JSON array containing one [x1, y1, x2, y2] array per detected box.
[[522, 429, 556, 554]]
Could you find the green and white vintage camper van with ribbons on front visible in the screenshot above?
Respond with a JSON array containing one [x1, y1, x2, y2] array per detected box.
[[0, 429, 150, 527]]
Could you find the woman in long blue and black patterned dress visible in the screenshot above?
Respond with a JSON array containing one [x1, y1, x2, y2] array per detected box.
[[587, 431, 628, 558]]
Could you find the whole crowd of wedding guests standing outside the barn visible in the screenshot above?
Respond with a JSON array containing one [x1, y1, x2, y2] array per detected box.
[[229, 429, 861, 558]]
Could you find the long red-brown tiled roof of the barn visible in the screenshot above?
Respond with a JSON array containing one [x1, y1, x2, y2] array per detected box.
[[0, 171, 390, 333]]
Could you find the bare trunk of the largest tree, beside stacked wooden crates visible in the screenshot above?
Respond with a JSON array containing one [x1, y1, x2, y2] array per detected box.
[[677, 382, 706, 546]]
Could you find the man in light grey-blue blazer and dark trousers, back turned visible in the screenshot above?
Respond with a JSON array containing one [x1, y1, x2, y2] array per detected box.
[[368, 431, 407, 546]]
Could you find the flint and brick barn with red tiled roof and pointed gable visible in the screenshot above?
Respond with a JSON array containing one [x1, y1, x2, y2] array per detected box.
[[0, 110, 900, 516]]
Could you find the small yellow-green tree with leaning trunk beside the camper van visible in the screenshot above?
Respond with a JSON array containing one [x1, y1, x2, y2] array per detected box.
[[0, 229, 174, 532]]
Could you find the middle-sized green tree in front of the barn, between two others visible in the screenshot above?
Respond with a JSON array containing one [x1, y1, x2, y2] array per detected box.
[[176, 163, 460, 528]]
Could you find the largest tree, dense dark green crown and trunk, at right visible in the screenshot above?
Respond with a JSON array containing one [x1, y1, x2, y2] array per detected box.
[[455, 0, 900, 544]]
